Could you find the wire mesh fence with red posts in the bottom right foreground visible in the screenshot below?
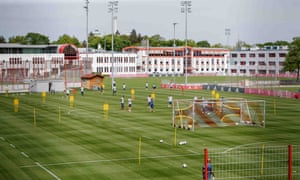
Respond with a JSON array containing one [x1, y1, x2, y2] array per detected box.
[[204, 145, 300, 180]]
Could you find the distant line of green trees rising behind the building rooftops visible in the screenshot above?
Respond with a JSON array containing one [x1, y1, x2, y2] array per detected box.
[[0, 29, 290, 51]]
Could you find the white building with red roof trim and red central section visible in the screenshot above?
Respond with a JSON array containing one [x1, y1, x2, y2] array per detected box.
[[123, 46, 229, 75]]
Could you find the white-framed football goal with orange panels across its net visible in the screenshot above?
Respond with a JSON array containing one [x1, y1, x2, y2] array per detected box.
[[172, 98, 265, 130]]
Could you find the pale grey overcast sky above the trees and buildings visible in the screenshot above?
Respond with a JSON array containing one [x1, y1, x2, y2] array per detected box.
[[0, 0, 300, 45]]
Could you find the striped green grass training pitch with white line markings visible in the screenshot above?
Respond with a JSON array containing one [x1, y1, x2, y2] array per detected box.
[[0, 77, 300, 180]]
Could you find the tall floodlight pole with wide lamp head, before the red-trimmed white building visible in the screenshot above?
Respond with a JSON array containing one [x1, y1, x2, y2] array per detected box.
[[181, 1, 192, 84]]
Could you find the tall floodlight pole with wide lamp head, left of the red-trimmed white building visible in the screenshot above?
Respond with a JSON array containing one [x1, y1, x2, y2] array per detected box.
[[108, 1, 119, 88]]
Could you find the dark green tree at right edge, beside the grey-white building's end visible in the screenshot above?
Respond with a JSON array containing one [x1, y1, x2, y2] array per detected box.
[[283, 37, 300, 81]]
